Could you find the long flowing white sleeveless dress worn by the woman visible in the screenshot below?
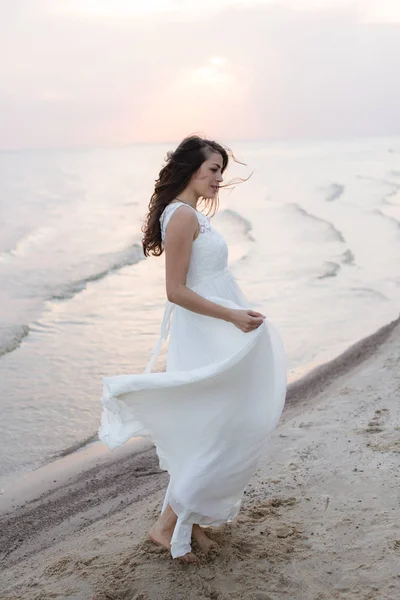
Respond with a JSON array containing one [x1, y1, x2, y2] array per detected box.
[[98, 201, 286, 558]]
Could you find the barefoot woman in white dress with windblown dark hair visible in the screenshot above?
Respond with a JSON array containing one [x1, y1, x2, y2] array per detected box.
[[99, 136, 286, 562]]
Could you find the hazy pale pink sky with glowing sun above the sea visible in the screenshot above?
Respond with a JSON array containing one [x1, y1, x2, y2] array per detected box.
[[0, 0, 400, 150]]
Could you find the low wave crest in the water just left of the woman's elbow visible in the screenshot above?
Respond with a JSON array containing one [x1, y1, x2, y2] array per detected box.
[[50, 244, 145, 300]]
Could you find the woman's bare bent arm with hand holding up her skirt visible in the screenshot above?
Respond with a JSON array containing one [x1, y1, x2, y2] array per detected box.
[[164, 206, 264, 331]]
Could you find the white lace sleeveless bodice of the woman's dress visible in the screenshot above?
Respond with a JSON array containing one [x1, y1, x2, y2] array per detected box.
[[160, 202, 228, 288]]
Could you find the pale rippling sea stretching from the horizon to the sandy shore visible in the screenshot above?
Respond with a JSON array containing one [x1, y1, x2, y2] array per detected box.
[[0, 137, 400, 492]]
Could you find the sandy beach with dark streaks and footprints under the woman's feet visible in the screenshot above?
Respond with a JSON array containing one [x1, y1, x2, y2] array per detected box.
[[0, 319, 400, 600]]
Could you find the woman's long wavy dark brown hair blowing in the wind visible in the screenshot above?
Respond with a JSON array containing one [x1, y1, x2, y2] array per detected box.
[[142, 135, 250, 256]]
